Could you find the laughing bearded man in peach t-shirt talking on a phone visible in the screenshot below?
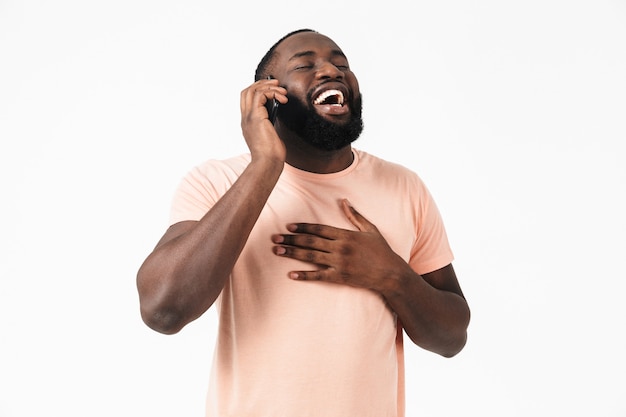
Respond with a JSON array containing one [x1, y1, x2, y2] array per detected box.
[[137, 30, 470, 417]]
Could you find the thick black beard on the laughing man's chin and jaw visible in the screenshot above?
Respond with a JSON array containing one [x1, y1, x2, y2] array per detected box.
[[277, 90, 363, 151]]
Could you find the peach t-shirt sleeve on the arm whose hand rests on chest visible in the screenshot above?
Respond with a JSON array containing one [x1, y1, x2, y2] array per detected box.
[[409, 179, 454, 275]]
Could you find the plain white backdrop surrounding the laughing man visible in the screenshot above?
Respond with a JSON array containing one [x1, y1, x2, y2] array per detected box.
[[0, 0, 626, 417]]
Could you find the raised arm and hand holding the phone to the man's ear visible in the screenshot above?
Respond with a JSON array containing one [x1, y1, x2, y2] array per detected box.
[[137, 80, 287, 334]]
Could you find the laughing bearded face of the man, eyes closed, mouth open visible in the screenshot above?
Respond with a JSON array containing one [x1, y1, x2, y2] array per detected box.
[[272, 32, 363, 150]]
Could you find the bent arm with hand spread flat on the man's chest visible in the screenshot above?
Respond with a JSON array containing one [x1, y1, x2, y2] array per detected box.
[[273, 201, 470, 357]]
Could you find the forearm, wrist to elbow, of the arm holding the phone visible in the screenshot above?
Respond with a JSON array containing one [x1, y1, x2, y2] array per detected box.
[[137, 160, 283, 333]]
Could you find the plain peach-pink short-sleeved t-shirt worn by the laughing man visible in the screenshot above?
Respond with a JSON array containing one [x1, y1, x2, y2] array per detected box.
[[170, 150, 453, 417]]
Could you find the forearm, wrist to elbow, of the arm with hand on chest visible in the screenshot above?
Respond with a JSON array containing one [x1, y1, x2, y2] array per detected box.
[[383, 268, 470, 357]]
